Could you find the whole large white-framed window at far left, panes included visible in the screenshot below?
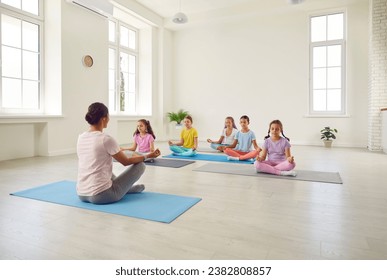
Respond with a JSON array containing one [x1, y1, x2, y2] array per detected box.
[[0, 0, 42, 113]]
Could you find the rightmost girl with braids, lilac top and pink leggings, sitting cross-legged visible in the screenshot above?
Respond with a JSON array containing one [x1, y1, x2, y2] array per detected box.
[[254, 120, 297, 176]]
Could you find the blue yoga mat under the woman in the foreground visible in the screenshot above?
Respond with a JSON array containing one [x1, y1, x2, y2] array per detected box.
[[11, 181, 201, 223]]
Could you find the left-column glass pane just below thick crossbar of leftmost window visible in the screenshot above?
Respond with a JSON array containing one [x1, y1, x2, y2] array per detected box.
[[1, 15, 21, 48]]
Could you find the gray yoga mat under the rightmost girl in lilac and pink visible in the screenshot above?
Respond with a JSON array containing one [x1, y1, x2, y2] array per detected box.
[[193, 163, 343, 184]]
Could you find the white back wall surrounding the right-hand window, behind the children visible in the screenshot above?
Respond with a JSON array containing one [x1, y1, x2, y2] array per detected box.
[[173, 1, 368, 147]]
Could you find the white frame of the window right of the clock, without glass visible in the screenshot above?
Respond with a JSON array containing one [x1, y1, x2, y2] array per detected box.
[[108, 18, 140, 116]]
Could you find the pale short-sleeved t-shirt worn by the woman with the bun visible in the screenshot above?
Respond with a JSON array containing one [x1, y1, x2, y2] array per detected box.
[[77, 131, 120, 196]]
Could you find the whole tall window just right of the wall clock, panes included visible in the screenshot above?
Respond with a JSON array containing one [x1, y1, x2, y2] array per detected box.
[[109, 20, 138, 115]]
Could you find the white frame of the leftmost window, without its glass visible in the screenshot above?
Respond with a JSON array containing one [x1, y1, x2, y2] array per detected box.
[[0, 0, 44, 116]]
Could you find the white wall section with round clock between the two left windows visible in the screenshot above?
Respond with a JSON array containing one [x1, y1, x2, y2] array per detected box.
[[48, 1, 108, 155]]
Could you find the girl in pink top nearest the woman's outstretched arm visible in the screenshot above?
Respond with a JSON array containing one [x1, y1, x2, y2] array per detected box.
[[122, 119, 156, 154]]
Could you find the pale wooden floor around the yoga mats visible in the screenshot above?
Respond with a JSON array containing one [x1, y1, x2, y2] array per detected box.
[[0, 144, 387, 260]]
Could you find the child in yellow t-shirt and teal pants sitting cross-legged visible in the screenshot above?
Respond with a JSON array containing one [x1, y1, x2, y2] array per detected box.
[[168, 116, 198, 156]]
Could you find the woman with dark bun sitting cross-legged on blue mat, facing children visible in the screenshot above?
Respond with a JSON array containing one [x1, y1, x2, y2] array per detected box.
[[77, 102, 160, 204]]
